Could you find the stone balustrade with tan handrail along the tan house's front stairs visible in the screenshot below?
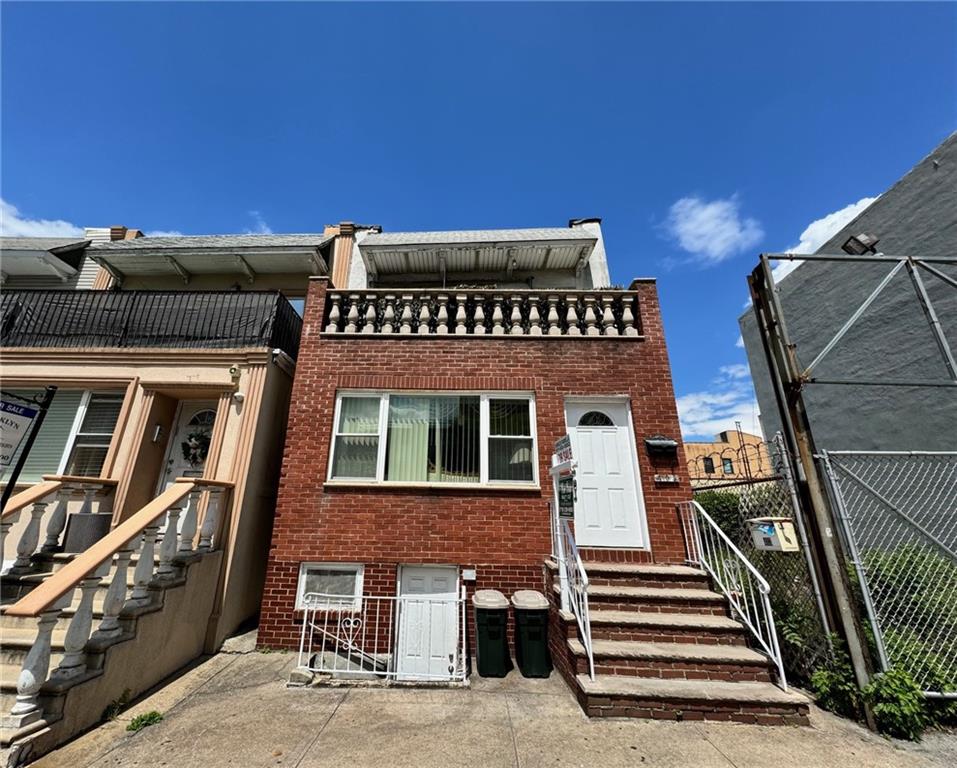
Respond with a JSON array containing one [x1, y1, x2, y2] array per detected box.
[[3, 478, 232, 729]]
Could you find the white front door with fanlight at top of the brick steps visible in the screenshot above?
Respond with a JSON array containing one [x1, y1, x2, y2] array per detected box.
[[565, 400, 645, 548]]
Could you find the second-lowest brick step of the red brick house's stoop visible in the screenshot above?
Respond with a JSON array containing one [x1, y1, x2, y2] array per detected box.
[[568, 639, 771, 683]]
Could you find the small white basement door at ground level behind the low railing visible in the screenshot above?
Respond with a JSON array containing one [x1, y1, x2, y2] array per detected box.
[[396, 565, 459, 680]]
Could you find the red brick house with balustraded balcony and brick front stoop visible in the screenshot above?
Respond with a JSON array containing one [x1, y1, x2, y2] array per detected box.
[[259, 219, 806, 722]]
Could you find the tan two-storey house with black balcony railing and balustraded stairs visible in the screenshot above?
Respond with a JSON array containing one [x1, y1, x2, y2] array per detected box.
[[0, 225, 352, 754]]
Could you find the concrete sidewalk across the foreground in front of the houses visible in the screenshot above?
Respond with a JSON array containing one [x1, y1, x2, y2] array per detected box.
[[26, 653, 957, 768]]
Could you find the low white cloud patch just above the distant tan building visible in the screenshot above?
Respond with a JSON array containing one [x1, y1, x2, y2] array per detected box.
[[677, 363, 761, 440]]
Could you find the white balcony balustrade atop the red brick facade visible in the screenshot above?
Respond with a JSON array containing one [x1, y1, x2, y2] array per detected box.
[[323, 289, 641, 338]]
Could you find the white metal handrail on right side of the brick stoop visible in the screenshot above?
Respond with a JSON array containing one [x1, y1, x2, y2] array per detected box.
[[677, 501, 788, 691]]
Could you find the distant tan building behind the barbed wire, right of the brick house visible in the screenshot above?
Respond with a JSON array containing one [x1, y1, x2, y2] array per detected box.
[[685, 430, 775, 487]]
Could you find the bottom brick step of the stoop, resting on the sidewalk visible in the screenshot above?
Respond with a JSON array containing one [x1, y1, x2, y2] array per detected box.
[[576, 674, 809, 725]]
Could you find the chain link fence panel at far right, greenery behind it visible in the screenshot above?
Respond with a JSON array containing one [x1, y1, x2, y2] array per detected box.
[[821, 451, 957, 698]]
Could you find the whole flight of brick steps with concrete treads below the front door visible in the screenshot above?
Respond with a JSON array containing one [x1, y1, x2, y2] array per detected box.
[[546, 560, 809, 725]]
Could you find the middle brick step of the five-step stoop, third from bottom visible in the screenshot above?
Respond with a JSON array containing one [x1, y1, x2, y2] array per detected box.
[[584, 609, 747, 646]]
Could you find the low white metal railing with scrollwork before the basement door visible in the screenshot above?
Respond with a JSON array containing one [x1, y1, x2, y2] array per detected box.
[[298, 586, 468, 682]]
